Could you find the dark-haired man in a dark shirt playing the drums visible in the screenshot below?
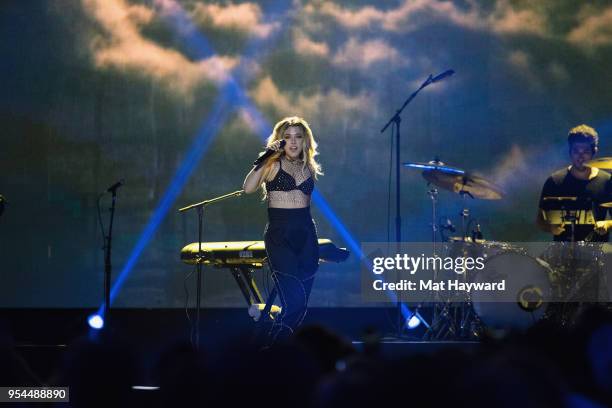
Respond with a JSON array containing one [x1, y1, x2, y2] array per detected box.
[[536, 125, 612, 242]]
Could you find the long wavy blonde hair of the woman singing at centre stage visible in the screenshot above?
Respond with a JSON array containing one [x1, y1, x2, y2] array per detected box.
[[261, 116, 323, 198]]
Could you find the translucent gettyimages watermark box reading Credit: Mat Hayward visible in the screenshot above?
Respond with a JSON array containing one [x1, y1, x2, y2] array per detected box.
[[361, 241, 612, 302]]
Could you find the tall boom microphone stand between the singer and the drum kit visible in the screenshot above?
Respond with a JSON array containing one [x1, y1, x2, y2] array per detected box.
[[380, 75, 435, 337]]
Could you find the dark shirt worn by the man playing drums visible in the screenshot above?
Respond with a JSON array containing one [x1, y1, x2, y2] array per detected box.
[[540, 167, 612, 242]]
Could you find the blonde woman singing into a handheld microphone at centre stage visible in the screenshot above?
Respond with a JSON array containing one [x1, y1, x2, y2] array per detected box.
[[243, 116, 323, 341]]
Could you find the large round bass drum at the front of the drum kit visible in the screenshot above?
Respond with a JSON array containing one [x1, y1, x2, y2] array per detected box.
[[472, 252, 552, 331]]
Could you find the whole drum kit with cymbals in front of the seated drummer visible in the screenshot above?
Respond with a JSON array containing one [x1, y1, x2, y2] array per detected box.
[[403, 158, 612, 340]]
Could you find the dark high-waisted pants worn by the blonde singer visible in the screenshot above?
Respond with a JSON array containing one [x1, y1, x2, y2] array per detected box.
[[264, 207, 319, 341]]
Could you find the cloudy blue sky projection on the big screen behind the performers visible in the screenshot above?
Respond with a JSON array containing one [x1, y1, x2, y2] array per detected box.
[[0, 0, 612, 307]]
